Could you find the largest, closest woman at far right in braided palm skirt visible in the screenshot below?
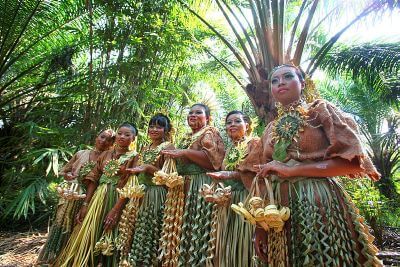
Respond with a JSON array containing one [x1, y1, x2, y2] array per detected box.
[[255, 65, 381, 266]]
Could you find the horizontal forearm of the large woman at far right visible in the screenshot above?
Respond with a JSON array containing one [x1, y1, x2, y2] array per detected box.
[[255, 158, 362, 178]]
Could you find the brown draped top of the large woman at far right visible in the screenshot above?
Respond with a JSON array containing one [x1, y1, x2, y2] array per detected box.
[[262, 99, 379, 180]]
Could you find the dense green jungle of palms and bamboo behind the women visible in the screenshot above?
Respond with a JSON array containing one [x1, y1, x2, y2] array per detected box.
[[0, 0, 400, 266]]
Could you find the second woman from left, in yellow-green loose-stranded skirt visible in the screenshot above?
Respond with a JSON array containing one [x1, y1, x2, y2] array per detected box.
[[57, 123, 137, 266]]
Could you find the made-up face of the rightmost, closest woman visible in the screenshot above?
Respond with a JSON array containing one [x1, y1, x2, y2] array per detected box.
[[271, 67, 304, 106]]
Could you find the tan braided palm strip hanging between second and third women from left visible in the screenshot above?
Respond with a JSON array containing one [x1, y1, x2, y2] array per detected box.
[[116, 198, 140, 266]]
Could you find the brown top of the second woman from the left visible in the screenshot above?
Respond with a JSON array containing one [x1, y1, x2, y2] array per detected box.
[[83, 149, 137, 188]]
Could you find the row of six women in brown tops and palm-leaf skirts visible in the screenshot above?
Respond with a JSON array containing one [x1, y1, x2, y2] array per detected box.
[[38, 65, 381, 266]]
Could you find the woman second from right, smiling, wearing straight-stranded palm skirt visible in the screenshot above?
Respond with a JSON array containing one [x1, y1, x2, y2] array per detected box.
[[207, 111, 260, 267]]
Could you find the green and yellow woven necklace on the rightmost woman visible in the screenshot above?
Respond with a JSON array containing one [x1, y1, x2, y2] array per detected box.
[[272, 99, 308, 162]]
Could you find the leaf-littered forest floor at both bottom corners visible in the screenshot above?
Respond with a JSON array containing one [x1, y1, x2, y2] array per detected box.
[[0, 228, 400, 267]]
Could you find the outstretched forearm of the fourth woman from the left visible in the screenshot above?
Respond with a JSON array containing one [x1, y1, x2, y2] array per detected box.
[[161, 149, 214, 170]]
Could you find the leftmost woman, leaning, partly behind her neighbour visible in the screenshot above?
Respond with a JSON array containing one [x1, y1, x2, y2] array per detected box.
[[38, 130, 115, 264]]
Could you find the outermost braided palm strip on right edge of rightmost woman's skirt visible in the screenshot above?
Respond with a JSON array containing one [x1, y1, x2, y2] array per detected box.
[[341, 188, 382, 266]]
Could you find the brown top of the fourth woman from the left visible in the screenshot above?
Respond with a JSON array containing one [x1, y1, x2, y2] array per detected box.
[[189, 126, 225, 170]]
